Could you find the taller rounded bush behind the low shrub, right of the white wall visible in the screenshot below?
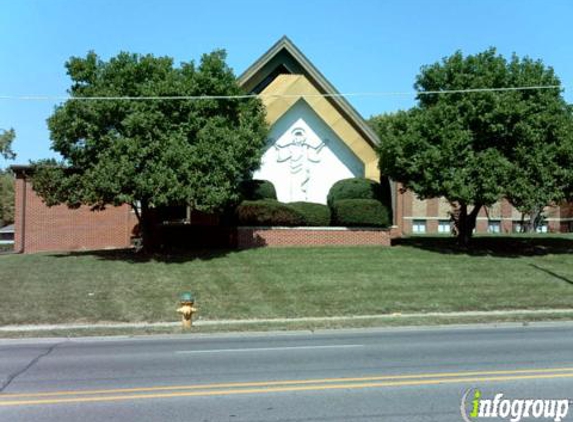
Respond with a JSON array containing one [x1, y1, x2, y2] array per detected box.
[[327, 177, 390, 207]]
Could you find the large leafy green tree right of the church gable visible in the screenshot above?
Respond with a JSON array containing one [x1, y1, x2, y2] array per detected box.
[[371, 48, 573, 244]]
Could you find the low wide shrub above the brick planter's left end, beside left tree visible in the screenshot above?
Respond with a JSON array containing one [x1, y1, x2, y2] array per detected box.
[[235, 199, 305, 226]]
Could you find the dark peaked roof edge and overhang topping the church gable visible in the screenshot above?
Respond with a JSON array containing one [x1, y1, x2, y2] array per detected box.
[[238, 35, 378, 146]]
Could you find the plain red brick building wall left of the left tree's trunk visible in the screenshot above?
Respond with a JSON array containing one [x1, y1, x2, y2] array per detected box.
[[14, 175, 136, 253]]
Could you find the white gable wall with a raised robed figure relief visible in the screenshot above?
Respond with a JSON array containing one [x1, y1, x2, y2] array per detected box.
[[253, 99, 364, 204]]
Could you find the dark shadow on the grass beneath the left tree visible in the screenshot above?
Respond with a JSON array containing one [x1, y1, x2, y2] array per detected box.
[[47, 248, 238, 264]]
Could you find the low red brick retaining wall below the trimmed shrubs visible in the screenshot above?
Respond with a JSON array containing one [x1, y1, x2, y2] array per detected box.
[[237, 227, 398, 249]]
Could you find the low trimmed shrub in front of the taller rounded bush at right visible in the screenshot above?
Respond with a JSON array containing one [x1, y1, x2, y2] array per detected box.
[[332, 199, 391, 227]]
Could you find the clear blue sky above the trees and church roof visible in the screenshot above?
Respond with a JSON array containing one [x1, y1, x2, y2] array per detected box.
[[0, 0, 573, 167]]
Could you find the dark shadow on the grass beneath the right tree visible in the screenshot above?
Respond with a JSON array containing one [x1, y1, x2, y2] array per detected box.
[[392, 235, 573, 258]]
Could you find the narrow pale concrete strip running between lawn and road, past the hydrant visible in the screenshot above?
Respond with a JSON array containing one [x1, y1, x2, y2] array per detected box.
[[0, 309, 573, 332]]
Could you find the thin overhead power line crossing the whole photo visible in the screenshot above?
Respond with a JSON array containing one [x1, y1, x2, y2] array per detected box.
[[0, 85, 565, 101]]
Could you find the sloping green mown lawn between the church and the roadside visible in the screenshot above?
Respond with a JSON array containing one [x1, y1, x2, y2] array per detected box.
[[0, 236, 573, 325]]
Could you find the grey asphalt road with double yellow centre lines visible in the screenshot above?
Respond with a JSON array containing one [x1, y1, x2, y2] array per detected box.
[[0, 324, 573, 422]]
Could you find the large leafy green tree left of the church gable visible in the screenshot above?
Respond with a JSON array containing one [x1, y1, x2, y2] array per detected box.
[[33, 51, 268, 249]]
